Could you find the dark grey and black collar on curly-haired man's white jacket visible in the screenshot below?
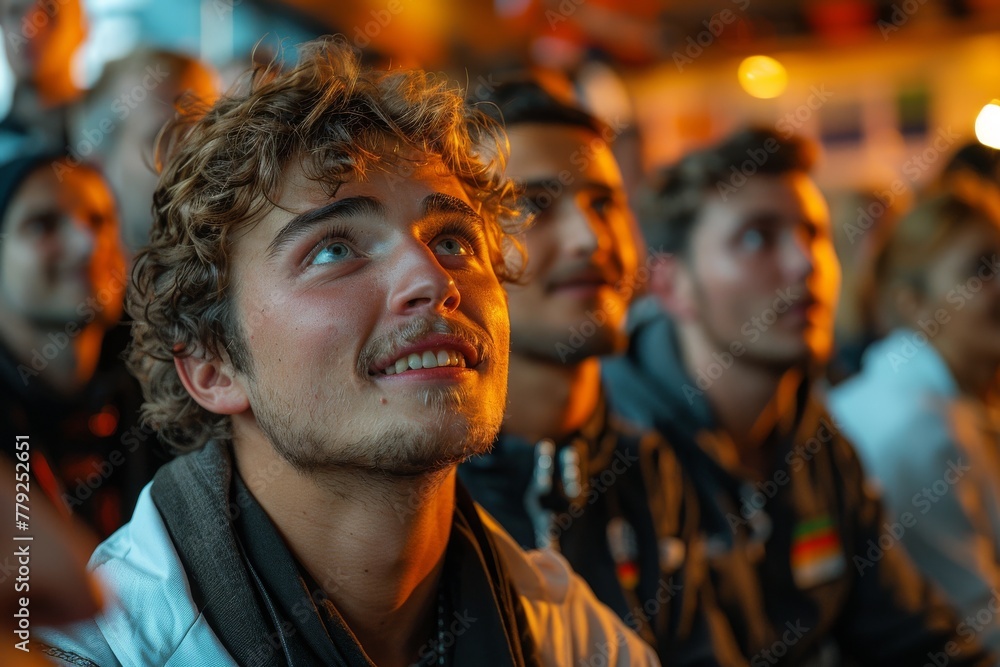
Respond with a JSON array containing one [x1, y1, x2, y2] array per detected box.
[[152, 442, 538, 667]]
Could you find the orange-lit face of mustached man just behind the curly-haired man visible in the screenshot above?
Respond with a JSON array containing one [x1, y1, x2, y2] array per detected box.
[[507, 123, 637, 361]]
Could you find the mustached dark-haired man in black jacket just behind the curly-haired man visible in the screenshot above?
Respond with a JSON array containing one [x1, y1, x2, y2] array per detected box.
[[459, 78, 736, 665]]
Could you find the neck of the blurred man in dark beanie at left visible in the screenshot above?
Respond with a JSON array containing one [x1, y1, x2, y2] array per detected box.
[[0, 308, 104, 396]]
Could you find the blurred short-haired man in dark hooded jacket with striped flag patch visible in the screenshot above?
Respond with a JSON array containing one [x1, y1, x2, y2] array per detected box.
[[605, 129, 992, 666]]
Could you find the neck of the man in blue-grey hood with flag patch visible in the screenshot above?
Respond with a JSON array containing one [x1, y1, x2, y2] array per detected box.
[[678, 326, 801, 474]]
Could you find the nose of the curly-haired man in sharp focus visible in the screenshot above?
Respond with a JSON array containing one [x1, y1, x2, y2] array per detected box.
[[389, 240, 461, 315]]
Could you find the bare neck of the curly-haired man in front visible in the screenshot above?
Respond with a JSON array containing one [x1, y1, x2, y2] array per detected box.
[[235, 436, 456, 666]]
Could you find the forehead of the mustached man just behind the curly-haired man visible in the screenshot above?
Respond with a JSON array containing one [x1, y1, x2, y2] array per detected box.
[[507, 123, 622, 188]]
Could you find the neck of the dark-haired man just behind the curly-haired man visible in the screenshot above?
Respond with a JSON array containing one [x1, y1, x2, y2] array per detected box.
[[503, 352, 601, 440]]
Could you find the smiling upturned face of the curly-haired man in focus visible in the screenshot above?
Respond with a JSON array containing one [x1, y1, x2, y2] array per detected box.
[[225, 158, 510, 475]]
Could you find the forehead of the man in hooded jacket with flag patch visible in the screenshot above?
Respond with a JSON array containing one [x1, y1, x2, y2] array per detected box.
[[699, 171, 830, 232]]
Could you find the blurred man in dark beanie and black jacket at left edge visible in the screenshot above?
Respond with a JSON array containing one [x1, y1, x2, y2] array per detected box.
[[0, 153, 155, 536]]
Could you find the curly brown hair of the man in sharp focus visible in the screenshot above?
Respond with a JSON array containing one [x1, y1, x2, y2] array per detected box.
[[128, 37, 523, 452]]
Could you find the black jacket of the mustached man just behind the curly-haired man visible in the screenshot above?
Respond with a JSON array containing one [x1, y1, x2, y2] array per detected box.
[[458, 403, 736, 667]]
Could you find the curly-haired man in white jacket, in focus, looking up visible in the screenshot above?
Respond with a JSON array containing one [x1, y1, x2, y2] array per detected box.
[[44, 39, 656, 665]]
